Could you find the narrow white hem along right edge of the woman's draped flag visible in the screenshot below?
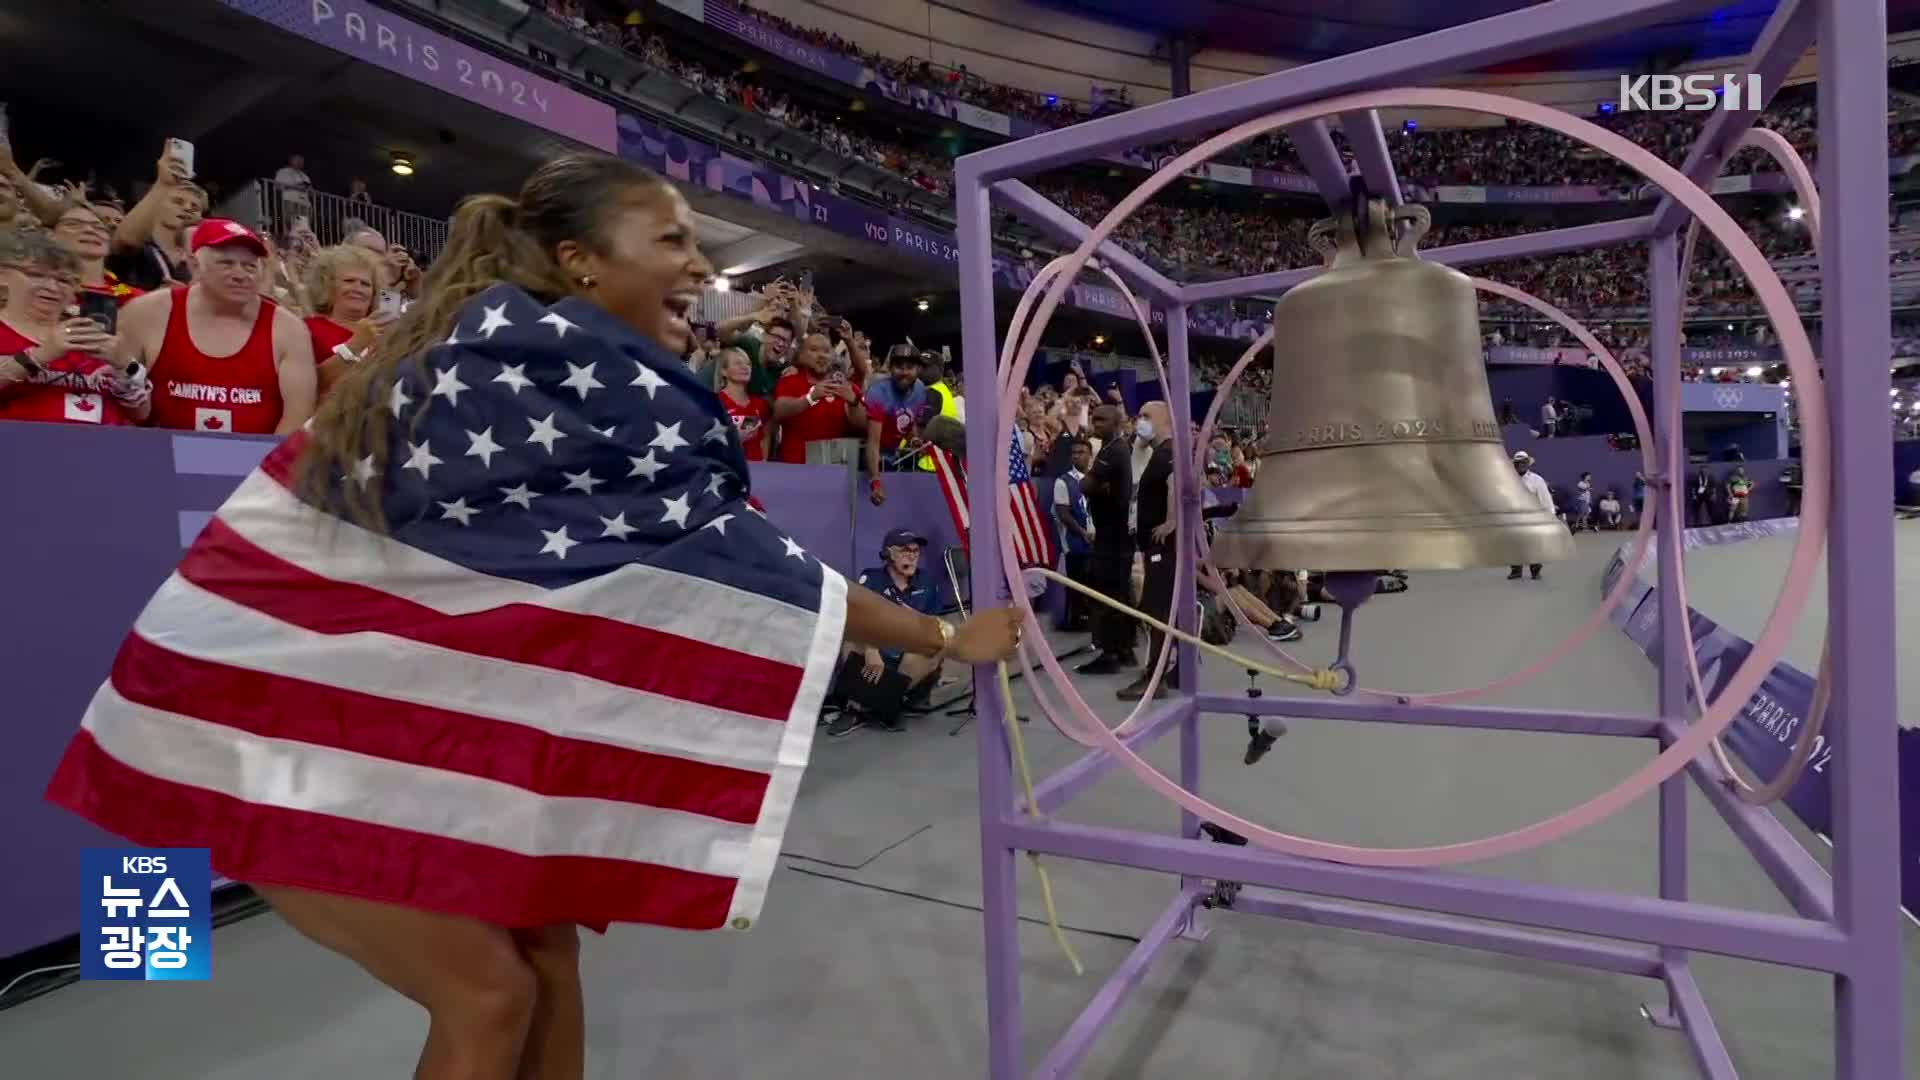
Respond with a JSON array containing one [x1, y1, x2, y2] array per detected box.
[[728, 565, 847, 928]]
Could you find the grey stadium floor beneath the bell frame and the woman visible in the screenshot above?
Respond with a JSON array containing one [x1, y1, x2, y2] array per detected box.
[[0, 538, 1920, 1080]]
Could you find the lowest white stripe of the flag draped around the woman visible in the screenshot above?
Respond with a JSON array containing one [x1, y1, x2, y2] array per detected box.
[[83, 682, 749, 878]]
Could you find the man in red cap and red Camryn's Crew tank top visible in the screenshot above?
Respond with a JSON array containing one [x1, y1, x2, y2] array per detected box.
[[119, 219, 315, 434]]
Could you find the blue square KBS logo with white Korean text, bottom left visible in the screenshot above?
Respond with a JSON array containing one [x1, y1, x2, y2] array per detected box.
[[81, 847, 213, 982]]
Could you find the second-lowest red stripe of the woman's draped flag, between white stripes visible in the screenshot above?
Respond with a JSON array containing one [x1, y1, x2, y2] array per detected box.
[[111, 634, 768, 824]]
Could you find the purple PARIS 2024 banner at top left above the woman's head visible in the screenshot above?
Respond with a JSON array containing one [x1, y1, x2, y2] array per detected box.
[[221, 0, 614, 150]]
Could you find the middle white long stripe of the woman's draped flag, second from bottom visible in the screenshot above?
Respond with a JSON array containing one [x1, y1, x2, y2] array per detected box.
[[134, 575, 791, 773]]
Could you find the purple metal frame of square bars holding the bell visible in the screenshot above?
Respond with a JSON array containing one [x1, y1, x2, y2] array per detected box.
[[954, 0, 1903, 1080]]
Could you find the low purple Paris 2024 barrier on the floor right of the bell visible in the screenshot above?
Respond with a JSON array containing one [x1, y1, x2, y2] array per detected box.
[[1607, 517, 1920, 913]]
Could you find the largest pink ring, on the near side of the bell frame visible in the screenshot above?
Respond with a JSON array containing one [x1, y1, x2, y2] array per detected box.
[[993, 88, 1830, 867]]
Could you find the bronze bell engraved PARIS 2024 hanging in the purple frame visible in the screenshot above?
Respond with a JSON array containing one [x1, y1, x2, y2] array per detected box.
[[1213, 198, 1572, 571]]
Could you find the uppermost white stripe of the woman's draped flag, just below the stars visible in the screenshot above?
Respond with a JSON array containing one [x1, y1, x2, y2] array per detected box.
[[219, 473, 816, 667]]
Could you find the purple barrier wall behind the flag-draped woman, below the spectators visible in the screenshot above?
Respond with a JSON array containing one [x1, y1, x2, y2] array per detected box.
[[0, 421, 956, 957]]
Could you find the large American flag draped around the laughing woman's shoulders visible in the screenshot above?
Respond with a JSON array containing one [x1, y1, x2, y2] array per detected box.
[[48, 286, 847, 928]]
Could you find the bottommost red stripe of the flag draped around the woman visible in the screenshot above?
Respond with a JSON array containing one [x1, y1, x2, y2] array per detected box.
[[46, 730, 733, 930]]
